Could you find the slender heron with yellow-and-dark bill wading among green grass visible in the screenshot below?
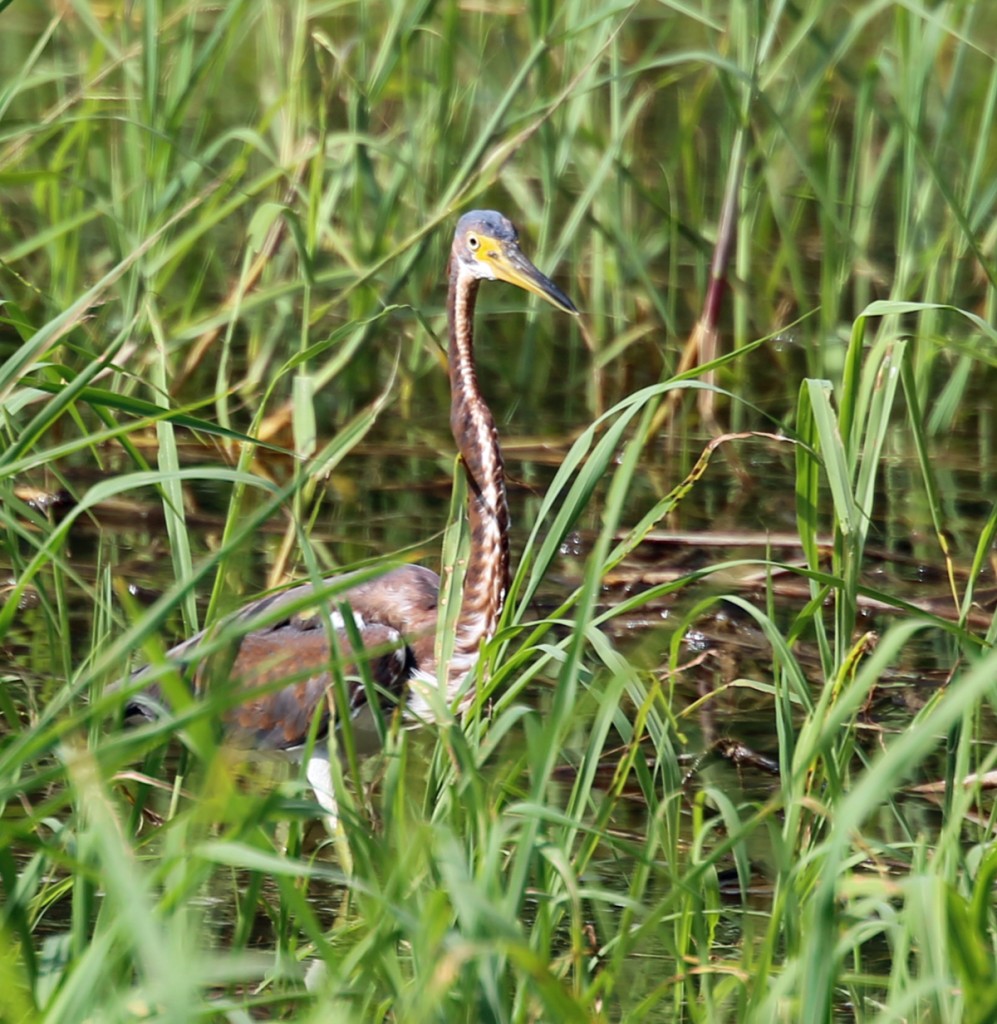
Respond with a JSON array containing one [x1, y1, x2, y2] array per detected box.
[[126, 210, 577, 818]]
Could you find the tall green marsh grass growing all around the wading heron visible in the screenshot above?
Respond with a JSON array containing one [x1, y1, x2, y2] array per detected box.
[[0, 0, 997, 1022]]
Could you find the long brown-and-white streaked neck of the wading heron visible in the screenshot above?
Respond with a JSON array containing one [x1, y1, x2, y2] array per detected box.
[[446, 268, 509, 697]]
